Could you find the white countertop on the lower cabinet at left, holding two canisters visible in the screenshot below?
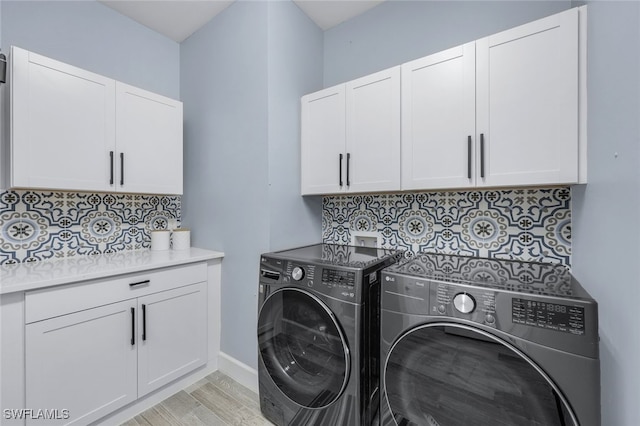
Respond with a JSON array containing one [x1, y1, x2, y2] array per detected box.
[[0, 248, 224, 294]]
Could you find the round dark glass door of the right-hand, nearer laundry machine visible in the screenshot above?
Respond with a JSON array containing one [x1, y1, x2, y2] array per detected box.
[[384, 323, 578, 426]]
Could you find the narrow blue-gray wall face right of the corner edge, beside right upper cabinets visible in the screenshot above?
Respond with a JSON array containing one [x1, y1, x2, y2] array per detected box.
[[268, 1, 323, 250]]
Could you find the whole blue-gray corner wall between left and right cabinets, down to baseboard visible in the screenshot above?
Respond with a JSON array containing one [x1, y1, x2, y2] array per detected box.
[[181, 1, 322, 368]]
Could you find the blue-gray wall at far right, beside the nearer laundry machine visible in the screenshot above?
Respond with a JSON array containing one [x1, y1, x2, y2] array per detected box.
[[573, 1, 640, 426]]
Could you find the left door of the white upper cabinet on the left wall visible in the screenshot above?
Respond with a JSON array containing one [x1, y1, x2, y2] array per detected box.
[[10, 47, 115, 191]]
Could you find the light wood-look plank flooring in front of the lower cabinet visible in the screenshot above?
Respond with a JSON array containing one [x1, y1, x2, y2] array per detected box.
[[122, 371, 272, 426]]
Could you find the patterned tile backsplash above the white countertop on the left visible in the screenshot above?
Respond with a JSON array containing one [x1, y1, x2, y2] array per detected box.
[[0, 190, 181, 264]]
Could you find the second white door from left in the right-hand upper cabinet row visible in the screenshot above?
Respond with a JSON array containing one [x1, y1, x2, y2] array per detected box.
[[344, 67, 400, 192]]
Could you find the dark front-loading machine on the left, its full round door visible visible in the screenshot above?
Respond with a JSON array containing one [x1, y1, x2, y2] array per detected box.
[[258, 244, 402, 426]]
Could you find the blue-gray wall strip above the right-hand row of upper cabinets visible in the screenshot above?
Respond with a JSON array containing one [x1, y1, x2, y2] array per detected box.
[[324, 0, 570, 87]]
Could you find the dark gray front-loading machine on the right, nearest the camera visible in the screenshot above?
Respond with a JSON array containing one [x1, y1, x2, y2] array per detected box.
[[380, 253, 600, 426]]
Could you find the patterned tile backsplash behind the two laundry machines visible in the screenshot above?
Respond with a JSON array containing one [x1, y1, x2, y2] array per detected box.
[[322, 188, 571, 266]]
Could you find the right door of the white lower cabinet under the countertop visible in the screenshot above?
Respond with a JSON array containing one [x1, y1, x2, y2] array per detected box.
[[138, 283, 207, 397]]
